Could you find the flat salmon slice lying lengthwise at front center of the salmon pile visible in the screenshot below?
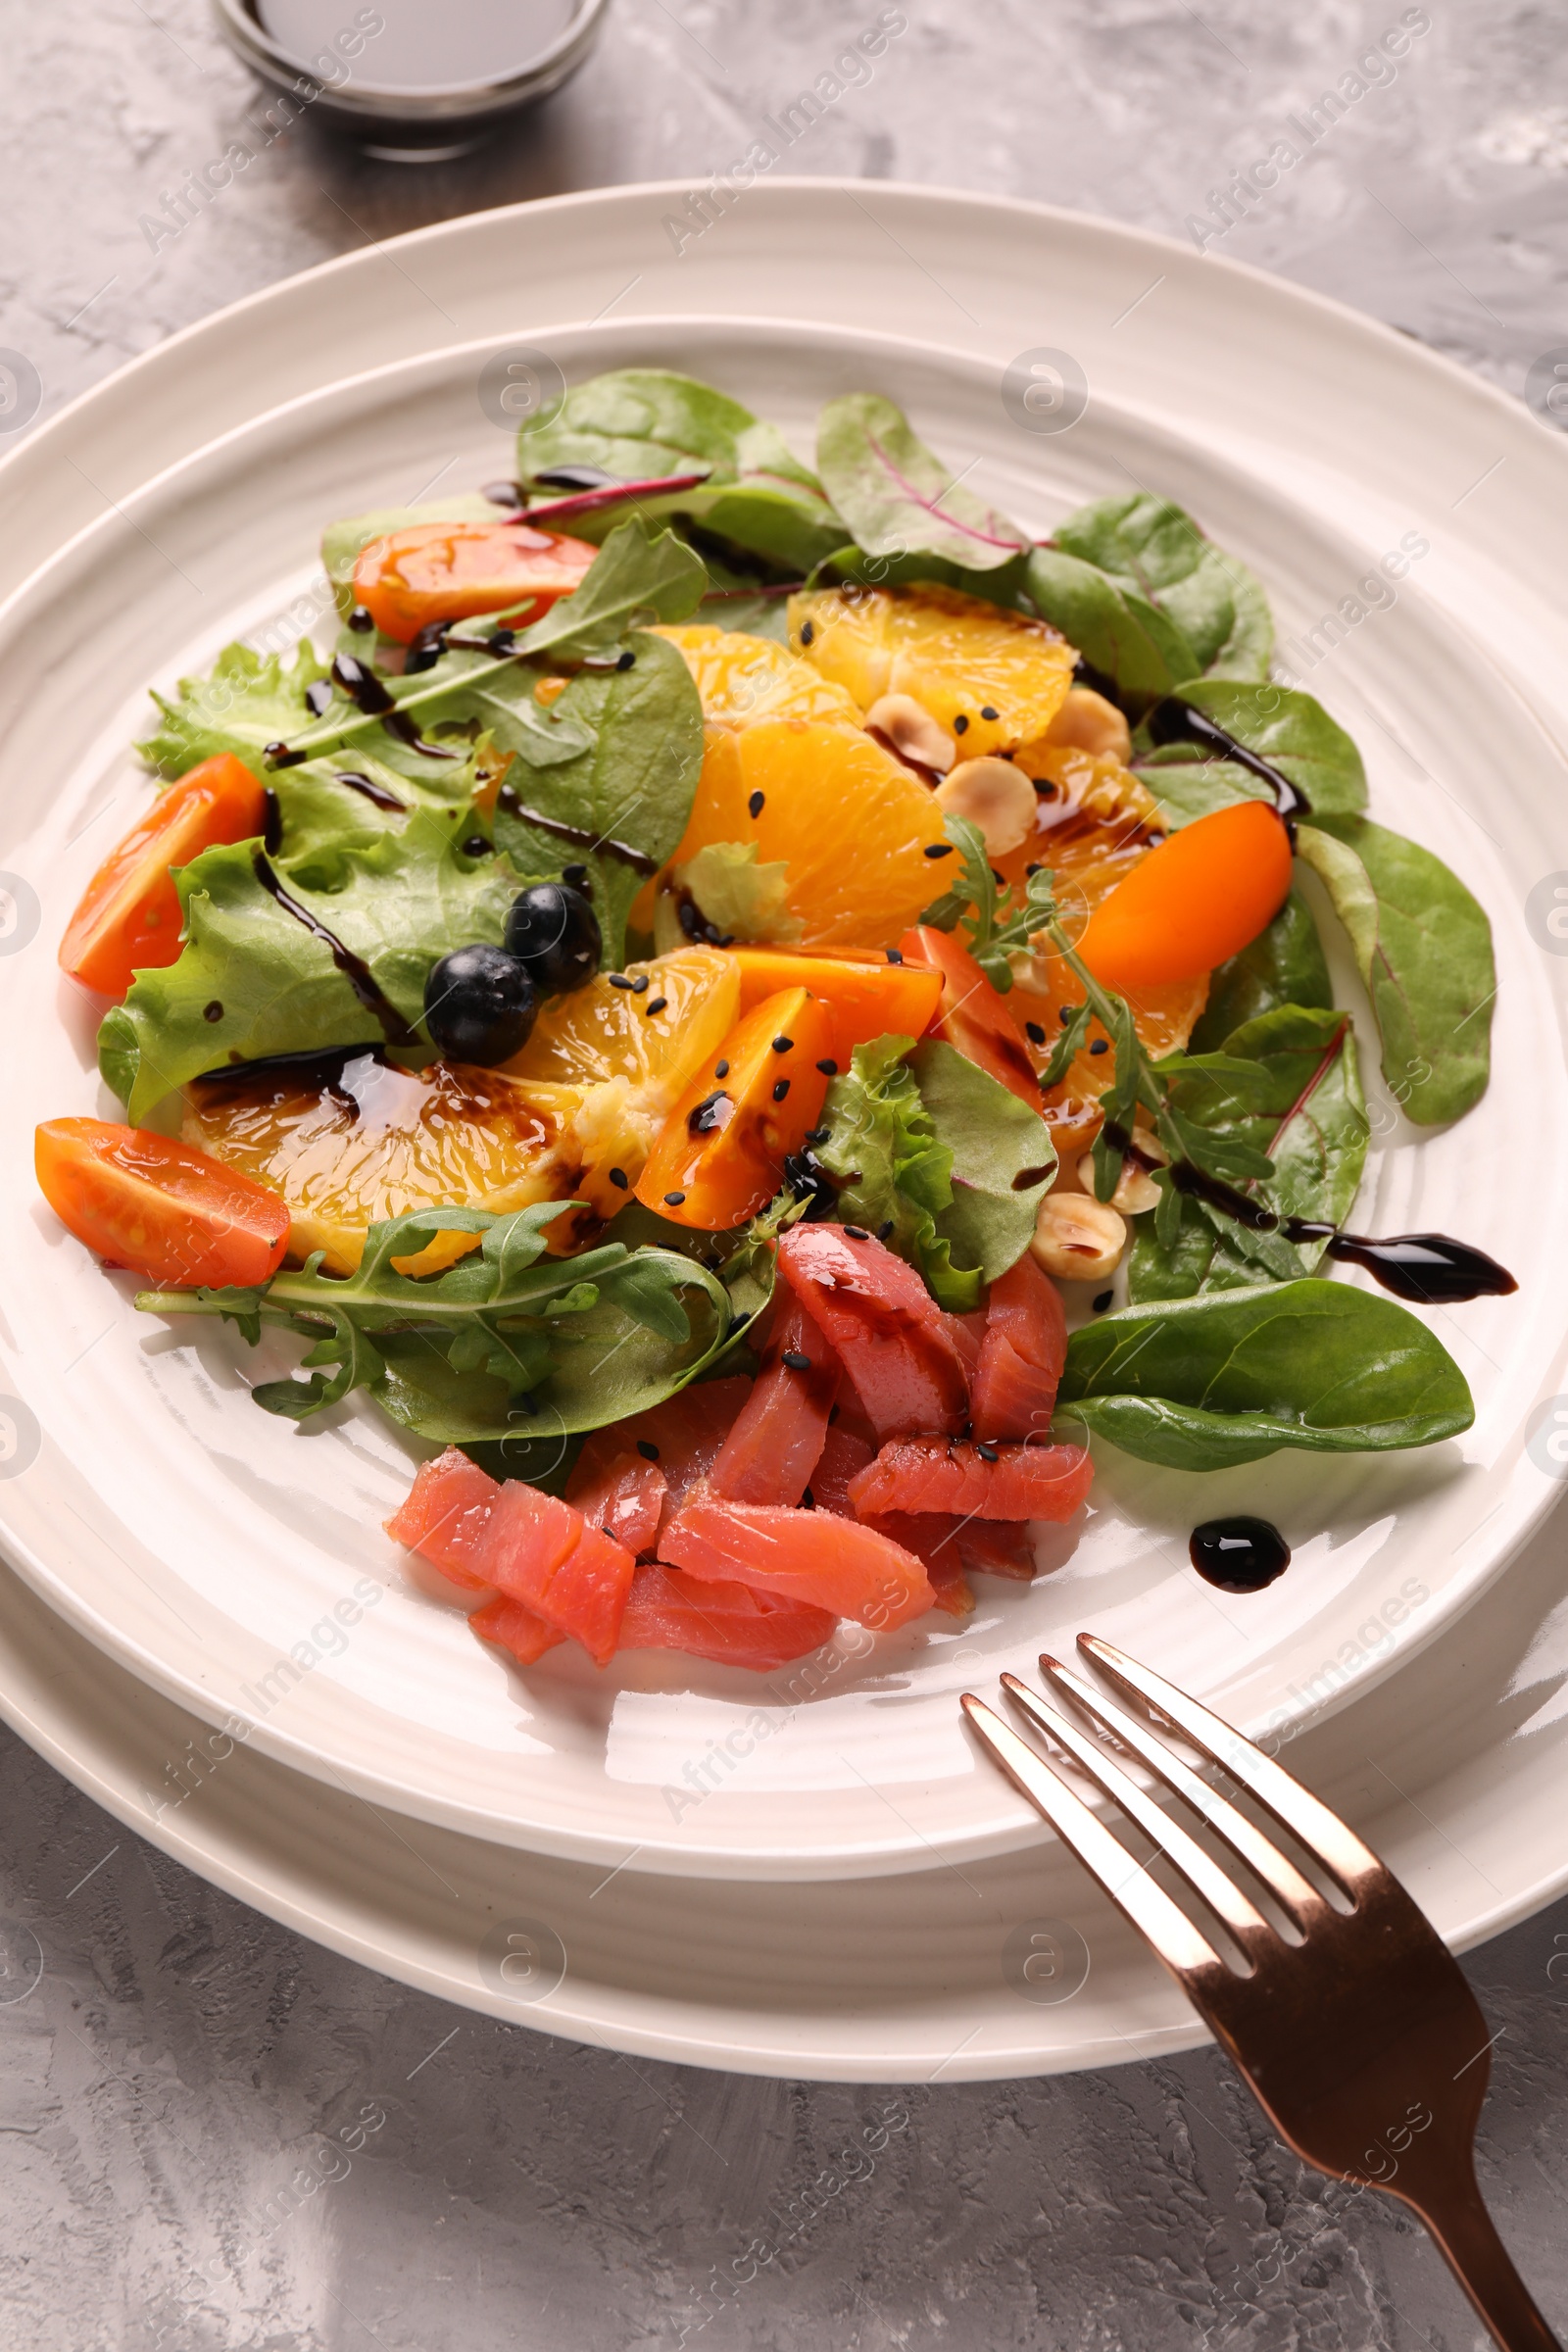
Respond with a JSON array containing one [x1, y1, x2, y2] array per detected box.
[[659, 1495, 936, 1633]]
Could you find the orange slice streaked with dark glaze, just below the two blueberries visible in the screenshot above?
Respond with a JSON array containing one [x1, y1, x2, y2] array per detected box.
[[181, 1052, 576, 1275]]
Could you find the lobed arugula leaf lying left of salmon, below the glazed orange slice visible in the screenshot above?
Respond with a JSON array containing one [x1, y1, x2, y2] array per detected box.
[[136, 1201, 752, 1445]]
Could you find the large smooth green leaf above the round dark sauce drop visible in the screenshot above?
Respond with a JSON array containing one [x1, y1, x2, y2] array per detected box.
[[1057, 1277, 1474, 1470]]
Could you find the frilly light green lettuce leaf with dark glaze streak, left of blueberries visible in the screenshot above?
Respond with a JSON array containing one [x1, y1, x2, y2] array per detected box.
[[99, 805, 526, 1124]]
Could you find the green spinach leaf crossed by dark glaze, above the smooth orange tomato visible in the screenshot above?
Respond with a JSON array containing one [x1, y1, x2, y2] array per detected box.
[[1133, 677, 1366, 825]]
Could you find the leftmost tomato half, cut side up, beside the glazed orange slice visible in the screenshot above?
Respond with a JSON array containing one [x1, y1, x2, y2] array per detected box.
[[33, 1119, 289, 1292]]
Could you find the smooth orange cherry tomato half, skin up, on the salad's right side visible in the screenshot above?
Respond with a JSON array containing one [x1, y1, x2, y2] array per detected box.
[[1079, 800, 1291, 988]]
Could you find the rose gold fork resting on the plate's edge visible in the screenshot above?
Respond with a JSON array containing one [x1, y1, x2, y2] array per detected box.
[[964, 1635, 1561, 2352]]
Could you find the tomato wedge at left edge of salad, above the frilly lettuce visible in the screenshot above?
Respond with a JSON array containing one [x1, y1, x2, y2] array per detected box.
[[59, 751, 266, 998]]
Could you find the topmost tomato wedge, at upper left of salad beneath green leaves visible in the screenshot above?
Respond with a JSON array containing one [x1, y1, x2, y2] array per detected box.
[[355, 522, 600, 645]]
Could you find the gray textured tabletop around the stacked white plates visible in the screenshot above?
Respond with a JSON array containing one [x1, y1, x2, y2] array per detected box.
[[0, 0, 1568, 2352]]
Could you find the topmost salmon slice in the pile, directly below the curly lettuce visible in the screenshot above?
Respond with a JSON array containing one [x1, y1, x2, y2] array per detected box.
[[778, 1225, 968, 1445]]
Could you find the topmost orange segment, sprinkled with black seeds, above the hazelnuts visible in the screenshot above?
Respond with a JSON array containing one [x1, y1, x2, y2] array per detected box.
[[790, 581, 1077, 760]]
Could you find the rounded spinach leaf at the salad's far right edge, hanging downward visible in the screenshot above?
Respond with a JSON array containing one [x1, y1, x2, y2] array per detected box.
[[1298, 816, 1497, 1127]]
